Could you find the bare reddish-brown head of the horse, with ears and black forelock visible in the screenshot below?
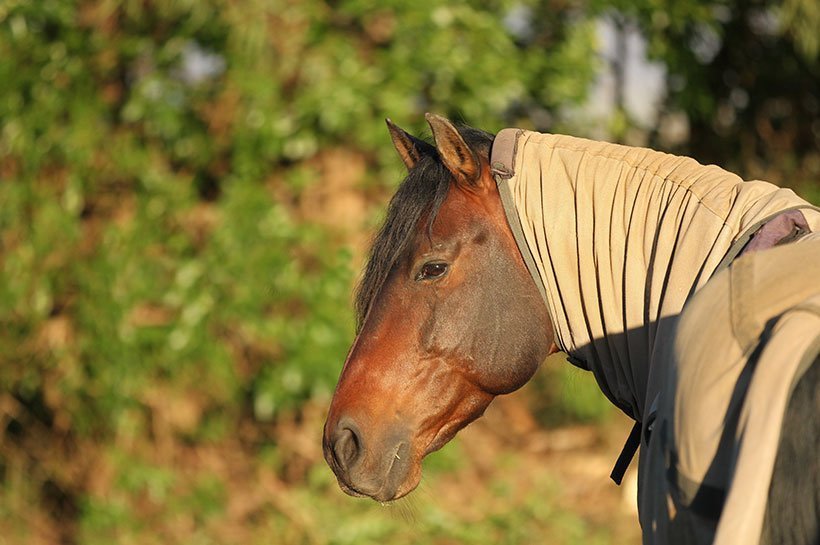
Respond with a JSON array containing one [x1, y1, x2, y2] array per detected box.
[[323, 114, 553, 501]]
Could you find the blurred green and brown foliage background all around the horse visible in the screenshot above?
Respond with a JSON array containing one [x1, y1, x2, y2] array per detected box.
[[0, 0, 820, 545]]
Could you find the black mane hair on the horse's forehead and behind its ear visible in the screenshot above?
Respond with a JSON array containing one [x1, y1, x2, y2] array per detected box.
[[355, 125, 494, 331]]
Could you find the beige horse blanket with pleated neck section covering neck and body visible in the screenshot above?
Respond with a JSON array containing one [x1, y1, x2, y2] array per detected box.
[[491, 129, 820, 544]]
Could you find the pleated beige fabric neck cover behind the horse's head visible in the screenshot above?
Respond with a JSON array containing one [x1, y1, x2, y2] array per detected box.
[[502, 133, 812, 419]]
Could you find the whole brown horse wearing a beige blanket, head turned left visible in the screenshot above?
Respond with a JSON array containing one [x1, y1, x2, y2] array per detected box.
[[322, 114, 820, 544]]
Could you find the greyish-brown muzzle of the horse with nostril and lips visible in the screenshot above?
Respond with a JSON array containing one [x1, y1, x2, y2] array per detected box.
[[323, 417, 414, 501]]
